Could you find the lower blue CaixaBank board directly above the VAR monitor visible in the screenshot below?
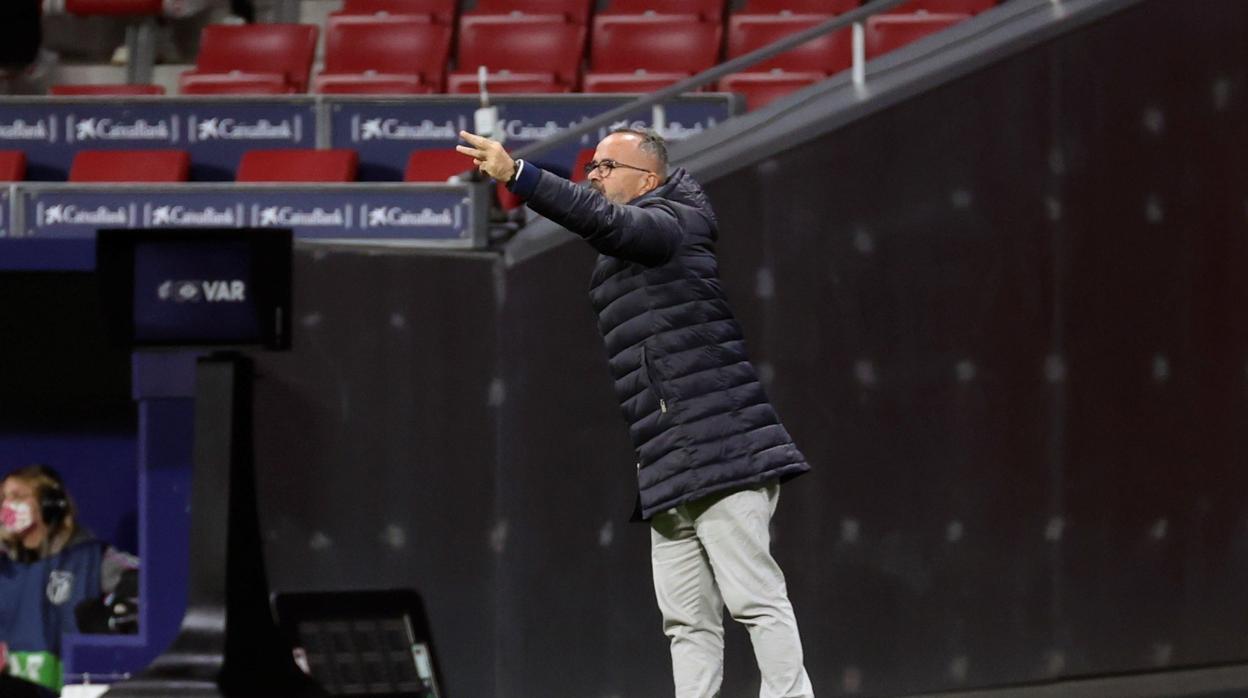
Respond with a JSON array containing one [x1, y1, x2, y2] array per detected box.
[[0, 184, 488, 270]]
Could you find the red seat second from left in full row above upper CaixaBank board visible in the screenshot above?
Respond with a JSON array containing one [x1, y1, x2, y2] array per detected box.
[[316, 17, 452, 94]]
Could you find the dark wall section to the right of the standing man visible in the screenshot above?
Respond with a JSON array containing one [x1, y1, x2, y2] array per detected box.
[[709, 2, 1248, 694]]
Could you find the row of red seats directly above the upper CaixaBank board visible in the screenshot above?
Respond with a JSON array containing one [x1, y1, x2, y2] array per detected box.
[[168, 14, 967, 94]]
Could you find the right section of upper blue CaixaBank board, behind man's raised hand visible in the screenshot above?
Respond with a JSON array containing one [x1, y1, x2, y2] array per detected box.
[[324, 94, 740, 181]]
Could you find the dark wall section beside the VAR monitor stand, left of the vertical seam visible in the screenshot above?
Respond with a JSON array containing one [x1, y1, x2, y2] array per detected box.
[[256, 251, 500, 696]]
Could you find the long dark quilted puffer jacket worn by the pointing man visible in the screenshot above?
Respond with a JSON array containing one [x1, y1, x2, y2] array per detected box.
[[512, 164, 810, 519]]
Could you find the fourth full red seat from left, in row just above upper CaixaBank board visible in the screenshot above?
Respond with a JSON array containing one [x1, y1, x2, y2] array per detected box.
[[589, 15, 724, 75]]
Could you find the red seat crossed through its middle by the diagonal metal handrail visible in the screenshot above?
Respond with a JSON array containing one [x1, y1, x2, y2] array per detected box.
[[728, 15, 854, 74]]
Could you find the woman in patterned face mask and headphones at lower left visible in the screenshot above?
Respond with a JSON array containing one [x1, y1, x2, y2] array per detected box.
[[0, 465, 139, 692]]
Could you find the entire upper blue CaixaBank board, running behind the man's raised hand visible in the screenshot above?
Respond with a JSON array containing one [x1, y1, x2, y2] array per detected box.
[[0, 94, 741, 181]]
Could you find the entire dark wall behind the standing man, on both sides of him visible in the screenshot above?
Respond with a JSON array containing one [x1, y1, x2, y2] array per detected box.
[[245, 0, 1248, 698]]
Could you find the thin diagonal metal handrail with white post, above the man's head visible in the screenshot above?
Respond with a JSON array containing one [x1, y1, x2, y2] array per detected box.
[[512, 0, 928, 159]]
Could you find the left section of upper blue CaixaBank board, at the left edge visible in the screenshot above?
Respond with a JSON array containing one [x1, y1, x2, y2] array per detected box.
[[0, 97, 317, 181]]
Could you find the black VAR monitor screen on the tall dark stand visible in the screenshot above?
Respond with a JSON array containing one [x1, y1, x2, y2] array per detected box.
[[96, 229, 291, 350]]
